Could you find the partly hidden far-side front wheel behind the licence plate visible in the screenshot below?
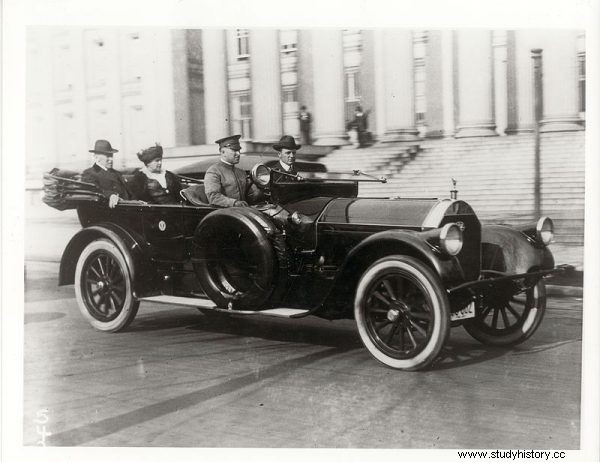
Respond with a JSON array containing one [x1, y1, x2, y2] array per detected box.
[[464, 280, 546, 346]]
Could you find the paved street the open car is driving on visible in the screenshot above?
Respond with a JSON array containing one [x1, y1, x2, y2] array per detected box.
[[23, 261, 582, 449]]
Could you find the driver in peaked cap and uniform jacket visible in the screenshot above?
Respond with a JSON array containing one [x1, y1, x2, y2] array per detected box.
[[204, 135, 261, 207]]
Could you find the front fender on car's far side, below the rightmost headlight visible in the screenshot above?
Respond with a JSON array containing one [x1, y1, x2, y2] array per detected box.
[[481, 225, 554, 275]]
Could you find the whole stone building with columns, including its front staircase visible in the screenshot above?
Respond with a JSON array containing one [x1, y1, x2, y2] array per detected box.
[[26, 27, 585, 249]]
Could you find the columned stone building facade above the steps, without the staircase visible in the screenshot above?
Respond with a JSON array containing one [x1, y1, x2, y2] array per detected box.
[[26, 27, 585, 179]]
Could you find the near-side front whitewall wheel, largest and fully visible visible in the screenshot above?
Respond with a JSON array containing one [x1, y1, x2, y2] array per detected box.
[[354, 255, 450, 371]]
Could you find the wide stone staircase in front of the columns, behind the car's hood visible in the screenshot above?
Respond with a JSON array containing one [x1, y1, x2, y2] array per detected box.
[[321, 132, 585, 246]]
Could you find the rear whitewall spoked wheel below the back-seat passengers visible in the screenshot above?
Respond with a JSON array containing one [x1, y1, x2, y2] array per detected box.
[[75, 239, 140, 332]]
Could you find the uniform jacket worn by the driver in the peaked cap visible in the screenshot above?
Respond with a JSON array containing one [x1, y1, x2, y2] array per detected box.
[[204, 162, 261, 207]]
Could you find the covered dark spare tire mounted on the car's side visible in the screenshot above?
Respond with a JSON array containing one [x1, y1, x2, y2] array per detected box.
[[193, 207, 287, 310]]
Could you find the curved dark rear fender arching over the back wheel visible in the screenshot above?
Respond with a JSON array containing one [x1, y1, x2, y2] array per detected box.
[[58, 223, 156, 297]]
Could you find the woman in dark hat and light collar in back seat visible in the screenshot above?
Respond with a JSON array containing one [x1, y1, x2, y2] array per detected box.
[[129, 144, 181, 204]]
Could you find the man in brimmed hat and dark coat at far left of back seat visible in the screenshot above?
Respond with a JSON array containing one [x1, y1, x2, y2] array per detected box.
[[81, 140, 131, 209]]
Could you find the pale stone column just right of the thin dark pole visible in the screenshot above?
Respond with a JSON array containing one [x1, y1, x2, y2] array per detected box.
[[540, 30, 583, 132]]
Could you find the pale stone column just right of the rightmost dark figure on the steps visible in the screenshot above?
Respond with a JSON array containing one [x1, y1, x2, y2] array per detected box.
[[382, 29, 419, 142]]
